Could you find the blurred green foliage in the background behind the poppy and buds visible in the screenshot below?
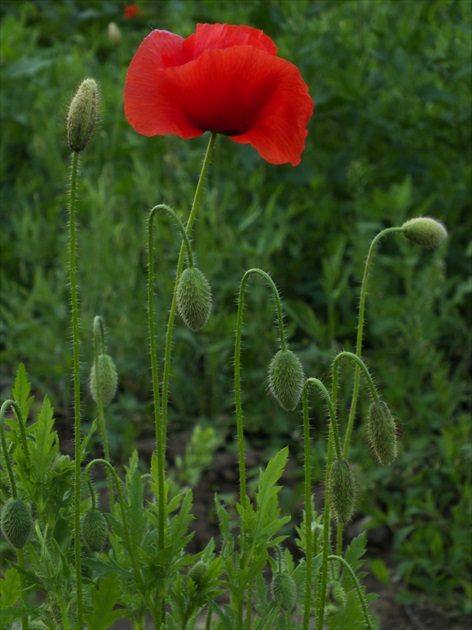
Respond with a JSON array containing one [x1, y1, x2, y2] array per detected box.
[[0, 0, 472, 607]]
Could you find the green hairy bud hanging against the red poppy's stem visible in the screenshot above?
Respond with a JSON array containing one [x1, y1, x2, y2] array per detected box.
[[177, 267, 211, 332]]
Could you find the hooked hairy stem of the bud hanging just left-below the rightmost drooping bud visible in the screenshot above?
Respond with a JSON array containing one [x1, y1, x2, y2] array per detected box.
[[302, 378, 341, 630]]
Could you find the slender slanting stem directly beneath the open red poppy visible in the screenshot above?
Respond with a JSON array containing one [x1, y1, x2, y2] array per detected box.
[[161, 132, 216, 444]]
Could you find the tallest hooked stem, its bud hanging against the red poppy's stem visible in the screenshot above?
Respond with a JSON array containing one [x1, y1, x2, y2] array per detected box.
[[148, 203, 193, 549]]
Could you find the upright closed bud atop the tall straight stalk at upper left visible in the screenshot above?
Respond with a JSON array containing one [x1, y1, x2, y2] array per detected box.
[[67, 79, 98, 152]]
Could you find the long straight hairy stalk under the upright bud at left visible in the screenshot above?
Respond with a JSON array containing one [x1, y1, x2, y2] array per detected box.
[[69, 151, 84, 628]]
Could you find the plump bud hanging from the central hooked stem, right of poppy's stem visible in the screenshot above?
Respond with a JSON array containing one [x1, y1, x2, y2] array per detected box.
[[268, 349, 303, 411]]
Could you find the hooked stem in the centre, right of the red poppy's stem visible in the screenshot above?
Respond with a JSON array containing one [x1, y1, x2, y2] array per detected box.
[[234, 268, 287, 507]]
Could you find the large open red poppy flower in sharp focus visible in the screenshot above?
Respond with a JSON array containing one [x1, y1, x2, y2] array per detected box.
[[124, 24, 313, 166]]
